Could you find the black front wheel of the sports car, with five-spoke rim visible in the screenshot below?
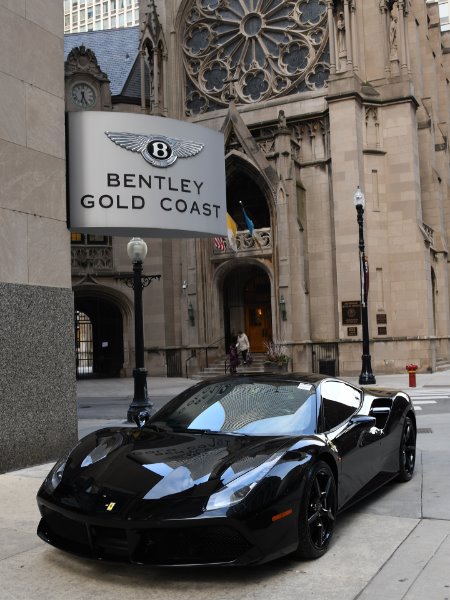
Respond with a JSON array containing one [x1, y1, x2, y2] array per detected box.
[[294, 461, 337, 559]]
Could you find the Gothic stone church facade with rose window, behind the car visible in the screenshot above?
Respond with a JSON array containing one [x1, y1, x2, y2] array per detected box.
[[66, 0, 450, 376]]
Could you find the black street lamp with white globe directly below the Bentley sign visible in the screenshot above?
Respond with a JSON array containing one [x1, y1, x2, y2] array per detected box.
[[125, 237, 161, 423]]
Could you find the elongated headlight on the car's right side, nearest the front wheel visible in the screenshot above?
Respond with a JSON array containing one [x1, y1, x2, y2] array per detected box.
[[206, 450, 284, 510]]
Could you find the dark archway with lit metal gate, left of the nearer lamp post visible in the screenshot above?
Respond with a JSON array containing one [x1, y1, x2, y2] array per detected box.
[[75, 294, 124, 378]]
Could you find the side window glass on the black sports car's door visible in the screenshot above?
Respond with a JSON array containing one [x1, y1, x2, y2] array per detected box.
[[321, 381, 361, 431]]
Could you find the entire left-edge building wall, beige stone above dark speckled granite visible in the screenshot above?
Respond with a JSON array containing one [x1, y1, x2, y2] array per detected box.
[[0, 0, 77, 472]]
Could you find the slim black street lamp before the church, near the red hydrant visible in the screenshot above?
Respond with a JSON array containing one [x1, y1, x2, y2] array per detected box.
[[353, 185, 376, 385]]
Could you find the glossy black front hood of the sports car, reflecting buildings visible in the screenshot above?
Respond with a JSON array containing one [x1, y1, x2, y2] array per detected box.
[[53, 428, 298, 510]]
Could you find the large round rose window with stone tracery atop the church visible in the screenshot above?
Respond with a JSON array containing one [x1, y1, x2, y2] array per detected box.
[[183, 0, 329, 114]]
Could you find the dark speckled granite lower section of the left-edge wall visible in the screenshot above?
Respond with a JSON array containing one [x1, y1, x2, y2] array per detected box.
[[0, 283, 77, 472]]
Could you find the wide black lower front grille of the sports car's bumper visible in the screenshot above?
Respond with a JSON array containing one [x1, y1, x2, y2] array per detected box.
[[38, 507, 251, 565]]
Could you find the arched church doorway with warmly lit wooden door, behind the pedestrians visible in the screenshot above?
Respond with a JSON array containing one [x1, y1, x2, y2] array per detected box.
[[223, 264, 272, 352]]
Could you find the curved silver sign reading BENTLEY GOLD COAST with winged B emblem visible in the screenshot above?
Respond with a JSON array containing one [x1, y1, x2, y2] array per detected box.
[[68, 111, 227, 237]]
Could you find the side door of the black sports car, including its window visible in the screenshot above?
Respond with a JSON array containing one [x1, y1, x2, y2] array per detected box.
[[320, 380, 380, 507]]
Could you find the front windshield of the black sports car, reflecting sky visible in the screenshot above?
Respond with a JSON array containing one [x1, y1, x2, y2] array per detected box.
[[147, 377, 317, 435]]
